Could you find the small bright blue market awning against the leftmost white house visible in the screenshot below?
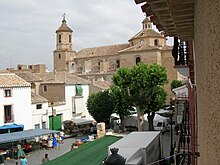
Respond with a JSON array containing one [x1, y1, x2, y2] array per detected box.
[[0, 123, 24, 134]]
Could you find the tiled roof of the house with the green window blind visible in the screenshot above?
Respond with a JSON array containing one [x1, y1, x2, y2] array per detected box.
[[35, 72, 91, 84]]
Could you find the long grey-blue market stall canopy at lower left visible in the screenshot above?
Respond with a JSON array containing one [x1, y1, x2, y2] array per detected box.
[[0, 129, 59, 144]]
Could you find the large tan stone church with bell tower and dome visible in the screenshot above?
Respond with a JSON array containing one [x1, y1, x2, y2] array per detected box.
[[53, 17, 181, 98]]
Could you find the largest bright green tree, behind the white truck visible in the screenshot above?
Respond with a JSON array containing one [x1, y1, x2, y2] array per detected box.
[[112, 63, 168, 131]]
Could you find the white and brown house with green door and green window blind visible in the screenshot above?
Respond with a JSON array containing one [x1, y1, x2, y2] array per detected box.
[[35, 72, 91, 129]]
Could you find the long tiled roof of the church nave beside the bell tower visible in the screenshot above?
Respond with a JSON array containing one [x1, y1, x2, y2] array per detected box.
[[76, 44, 129, 59]]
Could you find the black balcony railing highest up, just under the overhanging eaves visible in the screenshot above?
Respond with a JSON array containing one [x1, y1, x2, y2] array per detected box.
[[172, 37, 189, 66]]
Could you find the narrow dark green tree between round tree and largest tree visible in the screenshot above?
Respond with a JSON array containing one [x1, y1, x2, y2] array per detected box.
[[109, 85, 133, 131]]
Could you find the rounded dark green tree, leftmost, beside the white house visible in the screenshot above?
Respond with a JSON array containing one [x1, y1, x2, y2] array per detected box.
[[87, 90, 114, 126]]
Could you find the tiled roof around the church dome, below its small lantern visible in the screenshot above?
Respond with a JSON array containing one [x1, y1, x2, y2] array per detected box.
[[129, 29, 164, 41]]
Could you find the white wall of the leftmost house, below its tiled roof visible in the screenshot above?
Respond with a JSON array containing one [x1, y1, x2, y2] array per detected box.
[[0, 87, 33, 130]]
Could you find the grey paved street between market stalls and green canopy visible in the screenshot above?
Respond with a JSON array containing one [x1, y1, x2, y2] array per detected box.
[[5, 138, 75, 165]]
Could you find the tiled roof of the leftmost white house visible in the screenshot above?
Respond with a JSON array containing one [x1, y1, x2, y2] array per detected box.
[[0, 73, 31, 87]]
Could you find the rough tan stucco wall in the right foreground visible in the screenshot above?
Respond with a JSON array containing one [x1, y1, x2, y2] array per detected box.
[[194, 0, 220, 165]]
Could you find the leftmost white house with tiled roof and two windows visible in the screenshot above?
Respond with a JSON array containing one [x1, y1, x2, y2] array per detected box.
[[0, 73, 33, 130]]
